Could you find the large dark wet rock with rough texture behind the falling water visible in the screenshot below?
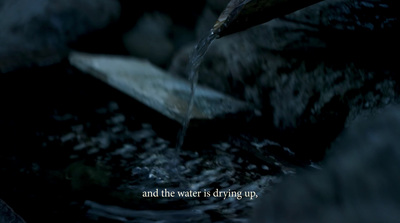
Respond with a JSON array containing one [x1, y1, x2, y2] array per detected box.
[[170, 0, 399, 158]]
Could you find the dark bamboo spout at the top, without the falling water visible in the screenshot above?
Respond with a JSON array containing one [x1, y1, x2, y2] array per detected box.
[[213, 0, 322, 38]]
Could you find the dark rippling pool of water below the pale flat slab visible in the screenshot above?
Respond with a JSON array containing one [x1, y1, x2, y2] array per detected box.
[[0, 64, 300, 223]]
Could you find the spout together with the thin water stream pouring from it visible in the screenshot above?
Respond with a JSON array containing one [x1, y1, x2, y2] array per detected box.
[[176, 0, 322, 150]]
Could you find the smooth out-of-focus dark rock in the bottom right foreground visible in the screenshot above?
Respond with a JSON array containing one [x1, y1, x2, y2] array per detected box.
[[252, 105, 400, 223]]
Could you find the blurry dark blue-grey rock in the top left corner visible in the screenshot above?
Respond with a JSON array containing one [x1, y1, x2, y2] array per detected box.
[[0, 0, 120, 73]]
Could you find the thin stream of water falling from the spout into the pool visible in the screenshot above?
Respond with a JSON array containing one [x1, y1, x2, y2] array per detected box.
[[176, 30, 217, 150]]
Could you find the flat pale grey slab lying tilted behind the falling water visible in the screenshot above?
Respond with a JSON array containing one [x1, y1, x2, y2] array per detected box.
[[70, 52, 250, 123]]
